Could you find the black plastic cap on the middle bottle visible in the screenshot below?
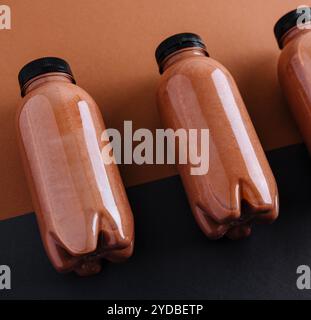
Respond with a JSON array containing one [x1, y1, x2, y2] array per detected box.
[[155, 33, 208, 73]]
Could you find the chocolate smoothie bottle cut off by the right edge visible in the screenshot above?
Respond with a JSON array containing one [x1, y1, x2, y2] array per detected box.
[[274, 8, 311, 153]]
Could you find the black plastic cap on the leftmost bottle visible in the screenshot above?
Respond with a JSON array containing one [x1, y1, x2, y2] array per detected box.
[[18, 57, 75, 97]]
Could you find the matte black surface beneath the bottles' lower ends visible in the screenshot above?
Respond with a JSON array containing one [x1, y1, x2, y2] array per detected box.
[[0, 145, 311, 299]]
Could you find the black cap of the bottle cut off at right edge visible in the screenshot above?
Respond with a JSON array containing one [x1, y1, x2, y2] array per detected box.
[[274, 7, 311, 49]]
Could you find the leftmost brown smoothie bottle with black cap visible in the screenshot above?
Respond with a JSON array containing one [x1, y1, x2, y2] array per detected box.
[[17, 58, 134, 275]]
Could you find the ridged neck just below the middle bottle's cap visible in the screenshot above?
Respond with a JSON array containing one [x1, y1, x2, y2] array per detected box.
[[159, 47, 209, 73]]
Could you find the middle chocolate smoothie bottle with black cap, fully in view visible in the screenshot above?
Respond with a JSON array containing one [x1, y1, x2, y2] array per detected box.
[[156, 33, 278, 239]]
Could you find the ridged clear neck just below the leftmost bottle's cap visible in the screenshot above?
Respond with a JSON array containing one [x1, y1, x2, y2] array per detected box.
[[22, 72, 75, 96]]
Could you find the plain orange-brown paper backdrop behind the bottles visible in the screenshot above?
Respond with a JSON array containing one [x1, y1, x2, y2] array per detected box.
[[0, 0, 304, 219]]
